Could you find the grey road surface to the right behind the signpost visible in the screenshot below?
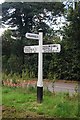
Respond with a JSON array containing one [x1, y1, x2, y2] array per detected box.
[[44, 81, 78, 94]]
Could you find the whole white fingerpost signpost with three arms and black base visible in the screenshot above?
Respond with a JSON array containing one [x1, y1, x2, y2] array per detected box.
[[24, 30, 61, 103]]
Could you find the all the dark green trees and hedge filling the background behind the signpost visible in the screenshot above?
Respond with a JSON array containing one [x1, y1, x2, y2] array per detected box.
[[2, 2, 80, 80]]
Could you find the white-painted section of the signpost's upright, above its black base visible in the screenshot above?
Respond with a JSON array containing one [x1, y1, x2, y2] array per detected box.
[[37, 32, 43, 87]]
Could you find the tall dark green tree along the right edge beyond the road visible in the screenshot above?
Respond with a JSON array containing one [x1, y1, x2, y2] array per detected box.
[[60, 2, 80, 80]]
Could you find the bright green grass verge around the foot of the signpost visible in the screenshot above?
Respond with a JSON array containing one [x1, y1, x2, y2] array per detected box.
[[2, 87, 78, 118]]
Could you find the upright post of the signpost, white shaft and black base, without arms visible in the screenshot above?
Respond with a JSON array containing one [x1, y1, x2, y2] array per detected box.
[[37, 32, 43, 103]]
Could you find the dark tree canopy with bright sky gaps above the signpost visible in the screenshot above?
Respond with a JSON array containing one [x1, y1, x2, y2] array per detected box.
[[2, 2, 64, 36]]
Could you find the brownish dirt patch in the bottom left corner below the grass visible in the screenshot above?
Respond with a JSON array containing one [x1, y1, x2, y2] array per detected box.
[[2, 106, 45, 118]]
